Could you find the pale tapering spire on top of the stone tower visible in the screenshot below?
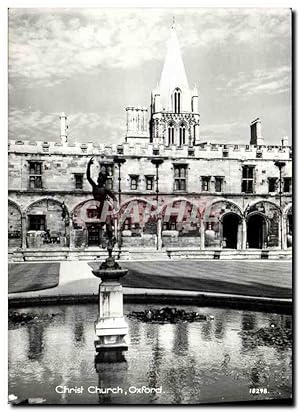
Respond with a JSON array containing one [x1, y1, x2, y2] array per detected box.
[[159, 17, 190, 110]]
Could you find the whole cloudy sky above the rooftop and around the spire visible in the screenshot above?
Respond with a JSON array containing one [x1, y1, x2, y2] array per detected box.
[[8, 8, 292, 145]]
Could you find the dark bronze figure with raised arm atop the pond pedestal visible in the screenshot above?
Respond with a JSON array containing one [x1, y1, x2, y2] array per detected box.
[[86, 157, 117, 258]]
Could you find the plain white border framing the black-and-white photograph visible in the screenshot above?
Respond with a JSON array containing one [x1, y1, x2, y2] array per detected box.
[[0, 0, 300, 411]]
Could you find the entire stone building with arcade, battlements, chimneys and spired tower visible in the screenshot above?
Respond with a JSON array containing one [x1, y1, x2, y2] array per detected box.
[[8, 27, 293, 258]]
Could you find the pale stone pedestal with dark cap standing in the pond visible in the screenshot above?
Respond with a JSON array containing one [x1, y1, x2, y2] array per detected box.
[[93, 264, 128, 351]]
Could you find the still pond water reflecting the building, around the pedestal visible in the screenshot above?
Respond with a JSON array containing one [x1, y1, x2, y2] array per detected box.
[[8, 304, 292, 404]]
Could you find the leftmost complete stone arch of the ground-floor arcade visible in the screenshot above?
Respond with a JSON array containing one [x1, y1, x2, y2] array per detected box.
[[25, 196, 70, 248]]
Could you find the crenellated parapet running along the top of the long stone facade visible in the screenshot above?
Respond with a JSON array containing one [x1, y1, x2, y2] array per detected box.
[[8, 140, 292, 160]]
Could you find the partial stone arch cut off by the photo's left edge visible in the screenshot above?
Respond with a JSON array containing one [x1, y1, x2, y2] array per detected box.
[[7, 199, 24, 248]]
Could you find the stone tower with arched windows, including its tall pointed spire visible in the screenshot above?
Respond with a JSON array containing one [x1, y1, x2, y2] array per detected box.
[[150, 23, 200, 146]]
